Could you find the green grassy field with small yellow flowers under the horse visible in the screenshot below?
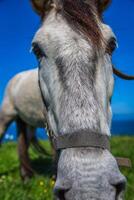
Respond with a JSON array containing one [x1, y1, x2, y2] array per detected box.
[[0, 137, 134, 200]]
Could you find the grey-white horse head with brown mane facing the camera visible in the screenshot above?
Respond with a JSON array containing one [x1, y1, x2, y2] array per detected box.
[[31, 0, 126, 200]]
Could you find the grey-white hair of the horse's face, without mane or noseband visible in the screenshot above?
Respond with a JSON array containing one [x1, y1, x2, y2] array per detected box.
[[33, 0, 125, 200]]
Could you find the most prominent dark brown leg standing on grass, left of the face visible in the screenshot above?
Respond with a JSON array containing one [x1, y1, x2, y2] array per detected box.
[[16, 118, 34, 181]]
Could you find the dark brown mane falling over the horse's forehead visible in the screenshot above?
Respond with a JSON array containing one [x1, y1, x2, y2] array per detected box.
[[59, 0, 103, 48]]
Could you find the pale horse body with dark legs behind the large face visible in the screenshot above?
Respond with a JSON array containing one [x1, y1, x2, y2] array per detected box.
[[0, 68, 48, 181]]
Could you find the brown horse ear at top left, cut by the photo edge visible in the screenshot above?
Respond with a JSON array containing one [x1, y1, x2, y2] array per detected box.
[[31, 0, 48, 16]]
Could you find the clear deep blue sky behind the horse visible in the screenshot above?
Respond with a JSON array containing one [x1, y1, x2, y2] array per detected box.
[[0, 0, 134, 123]]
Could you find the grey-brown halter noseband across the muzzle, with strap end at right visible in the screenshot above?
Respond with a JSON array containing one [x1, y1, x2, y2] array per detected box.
[[51, 130, 132, 168]]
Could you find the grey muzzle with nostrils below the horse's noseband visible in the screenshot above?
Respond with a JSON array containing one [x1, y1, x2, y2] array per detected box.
[[54, 148, 126, 200]]
